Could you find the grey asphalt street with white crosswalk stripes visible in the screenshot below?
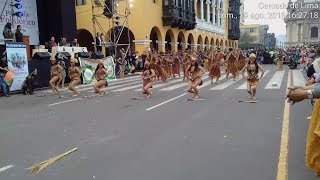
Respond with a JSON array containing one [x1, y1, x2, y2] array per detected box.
[[0, 65, 315, 180]]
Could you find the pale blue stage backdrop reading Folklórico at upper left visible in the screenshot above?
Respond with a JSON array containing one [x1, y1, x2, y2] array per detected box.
[[0, 0, 39, 45]]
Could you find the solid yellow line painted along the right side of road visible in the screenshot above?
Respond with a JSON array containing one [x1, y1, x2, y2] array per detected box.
[[277, 70, 292, 180]]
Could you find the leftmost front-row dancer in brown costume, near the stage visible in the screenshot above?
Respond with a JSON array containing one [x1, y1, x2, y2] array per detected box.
[[49, 58, 63, 95]]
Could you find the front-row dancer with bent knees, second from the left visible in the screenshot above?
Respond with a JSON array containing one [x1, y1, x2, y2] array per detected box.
[[68, 58, 81, 96]]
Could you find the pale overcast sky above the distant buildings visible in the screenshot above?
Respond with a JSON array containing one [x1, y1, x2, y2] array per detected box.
[[244, 0, 288, 35]]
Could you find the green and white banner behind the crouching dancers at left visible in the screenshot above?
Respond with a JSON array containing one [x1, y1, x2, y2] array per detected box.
[[80, 56, 116, 84]]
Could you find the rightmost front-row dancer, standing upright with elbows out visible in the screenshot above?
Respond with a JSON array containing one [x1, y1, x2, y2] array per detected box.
[[241, 53, 264, 100]]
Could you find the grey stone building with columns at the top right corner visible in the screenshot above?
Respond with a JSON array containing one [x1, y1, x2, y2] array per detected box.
[[285, 0, 320, 46]]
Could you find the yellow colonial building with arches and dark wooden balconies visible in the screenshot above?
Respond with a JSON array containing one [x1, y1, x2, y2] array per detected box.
[[76, 0, 239, 52]]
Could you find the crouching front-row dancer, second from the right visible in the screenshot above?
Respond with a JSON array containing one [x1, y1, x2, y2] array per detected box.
[[186, 57, 205, 99]]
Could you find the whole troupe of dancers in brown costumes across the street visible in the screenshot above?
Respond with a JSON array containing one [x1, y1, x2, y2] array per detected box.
[[49, 48, 264, 99]]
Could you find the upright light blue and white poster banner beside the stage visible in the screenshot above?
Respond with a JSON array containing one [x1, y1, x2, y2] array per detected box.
[[6, 43, 29, 91]]
